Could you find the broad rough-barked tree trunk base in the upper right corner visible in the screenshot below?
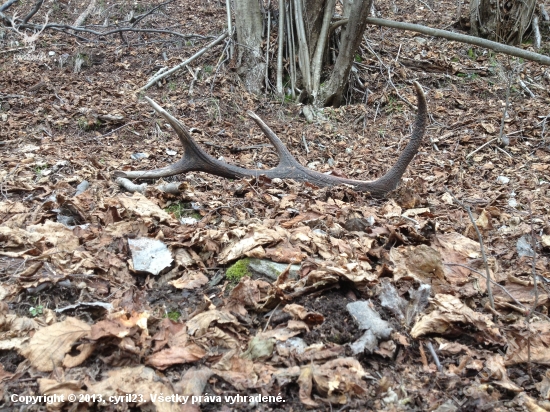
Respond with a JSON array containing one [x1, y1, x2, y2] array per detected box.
[[470, 0, 536, 45]]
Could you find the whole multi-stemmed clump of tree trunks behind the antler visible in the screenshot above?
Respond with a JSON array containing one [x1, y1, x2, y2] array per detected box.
[[234, 0, 373, 107]]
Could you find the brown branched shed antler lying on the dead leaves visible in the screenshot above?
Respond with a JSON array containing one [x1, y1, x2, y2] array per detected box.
[[115, 82, 428, 197]]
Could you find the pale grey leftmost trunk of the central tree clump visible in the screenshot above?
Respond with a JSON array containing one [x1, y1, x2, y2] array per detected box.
[[235, 0, 265, 94]]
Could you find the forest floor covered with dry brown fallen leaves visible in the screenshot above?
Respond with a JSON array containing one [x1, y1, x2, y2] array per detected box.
[[0, 0, 550, 412]]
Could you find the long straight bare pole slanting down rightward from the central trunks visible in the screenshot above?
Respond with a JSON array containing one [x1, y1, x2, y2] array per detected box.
[[367, 17, 550, 66]]
